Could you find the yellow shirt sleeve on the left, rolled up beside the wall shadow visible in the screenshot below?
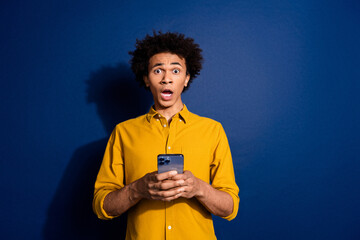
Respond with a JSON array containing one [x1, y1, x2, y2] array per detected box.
[[93, 128, 124, 219]]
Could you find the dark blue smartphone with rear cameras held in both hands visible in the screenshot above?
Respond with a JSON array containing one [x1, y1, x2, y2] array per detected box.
[[158, 154, 184, 173]]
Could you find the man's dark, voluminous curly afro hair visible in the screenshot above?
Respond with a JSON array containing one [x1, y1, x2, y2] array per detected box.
[[129, 31, 203, 91]]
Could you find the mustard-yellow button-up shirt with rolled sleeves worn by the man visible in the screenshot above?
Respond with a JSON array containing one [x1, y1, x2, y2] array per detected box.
[[93, 105, 239, 240]]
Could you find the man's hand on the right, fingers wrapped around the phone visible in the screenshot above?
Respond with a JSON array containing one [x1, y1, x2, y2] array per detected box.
[[171, 171, 204, 198]]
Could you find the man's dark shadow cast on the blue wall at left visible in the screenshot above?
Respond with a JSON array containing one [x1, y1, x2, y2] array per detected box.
[[43, 64, 152, 240]]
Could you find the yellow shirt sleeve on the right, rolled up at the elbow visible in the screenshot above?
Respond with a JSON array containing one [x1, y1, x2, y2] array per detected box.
[[210, 124, 240, 221]]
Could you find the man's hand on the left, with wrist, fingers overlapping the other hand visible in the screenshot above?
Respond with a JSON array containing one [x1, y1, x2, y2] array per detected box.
[[130, 171, 184, 201]]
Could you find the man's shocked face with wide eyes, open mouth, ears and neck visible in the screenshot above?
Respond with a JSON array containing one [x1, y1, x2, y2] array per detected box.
[[144, 53, 190, 110]]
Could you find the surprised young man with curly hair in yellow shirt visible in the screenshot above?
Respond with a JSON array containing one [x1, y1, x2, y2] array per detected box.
[[93, 33, 239, 240]]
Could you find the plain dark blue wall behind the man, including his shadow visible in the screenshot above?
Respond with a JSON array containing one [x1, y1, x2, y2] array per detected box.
[[0, 0, 360, 239]]
